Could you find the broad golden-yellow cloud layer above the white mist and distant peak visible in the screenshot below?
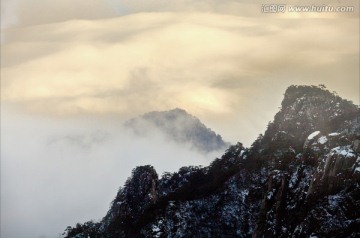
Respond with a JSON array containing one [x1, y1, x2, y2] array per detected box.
[[1, 13, 359, 143]]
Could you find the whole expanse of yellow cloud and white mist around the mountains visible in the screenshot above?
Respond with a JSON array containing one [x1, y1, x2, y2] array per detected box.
[[1, 0, 360, 238]]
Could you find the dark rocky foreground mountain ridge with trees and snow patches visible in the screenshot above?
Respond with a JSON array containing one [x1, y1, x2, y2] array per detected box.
[[65, 86, 360, 238]]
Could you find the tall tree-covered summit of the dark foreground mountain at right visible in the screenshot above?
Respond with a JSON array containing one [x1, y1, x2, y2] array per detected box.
[[261, 85, 359, 151]]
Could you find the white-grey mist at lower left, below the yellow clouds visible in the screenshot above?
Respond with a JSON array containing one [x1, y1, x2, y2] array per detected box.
[[1, 106, 223, 238]]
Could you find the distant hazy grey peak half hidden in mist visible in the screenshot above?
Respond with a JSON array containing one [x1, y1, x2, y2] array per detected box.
[[125, 108, 229, 152]]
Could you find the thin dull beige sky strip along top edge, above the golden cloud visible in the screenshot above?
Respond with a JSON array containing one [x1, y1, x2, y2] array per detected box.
[[1, 0, 359, 27]]
